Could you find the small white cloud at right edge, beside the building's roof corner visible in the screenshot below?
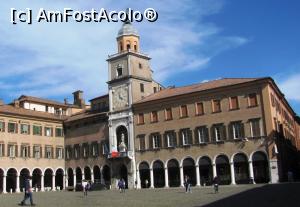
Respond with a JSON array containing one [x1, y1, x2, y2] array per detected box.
[[279, 73, 300, 102]]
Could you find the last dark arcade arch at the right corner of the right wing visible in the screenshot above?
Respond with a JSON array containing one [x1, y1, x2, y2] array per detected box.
[[252, 152, 270, 183]]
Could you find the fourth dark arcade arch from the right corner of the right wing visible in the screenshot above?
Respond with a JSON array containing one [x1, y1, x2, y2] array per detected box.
[[199, 156, 213, 186]]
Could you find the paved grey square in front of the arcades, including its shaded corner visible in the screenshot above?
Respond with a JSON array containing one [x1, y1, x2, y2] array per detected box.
[[0, 183, 300, 207]]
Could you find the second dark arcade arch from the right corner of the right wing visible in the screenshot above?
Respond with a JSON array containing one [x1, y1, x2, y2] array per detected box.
[[233, 153, 250, 184]]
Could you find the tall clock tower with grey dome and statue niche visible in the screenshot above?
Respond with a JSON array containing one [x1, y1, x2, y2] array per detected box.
[[107, 21, 161, 188]]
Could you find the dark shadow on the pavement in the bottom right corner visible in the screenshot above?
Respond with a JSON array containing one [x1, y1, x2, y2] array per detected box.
[[197, 183, 300, 207]]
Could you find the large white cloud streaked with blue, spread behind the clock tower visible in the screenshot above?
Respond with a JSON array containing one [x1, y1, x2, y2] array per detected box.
[[0, 0, 247, 100]]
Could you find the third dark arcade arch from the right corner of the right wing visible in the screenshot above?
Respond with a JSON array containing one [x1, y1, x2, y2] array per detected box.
[[216, 155, 231, 185]]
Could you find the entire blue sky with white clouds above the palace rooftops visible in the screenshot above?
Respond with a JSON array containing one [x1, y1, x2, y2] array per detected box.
[[0, 0, 300, 115]]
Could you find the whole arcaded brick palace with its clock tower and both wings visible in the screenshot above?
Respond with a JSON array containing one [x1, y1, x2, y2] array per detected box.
[[0, 22, 300, 193]]
